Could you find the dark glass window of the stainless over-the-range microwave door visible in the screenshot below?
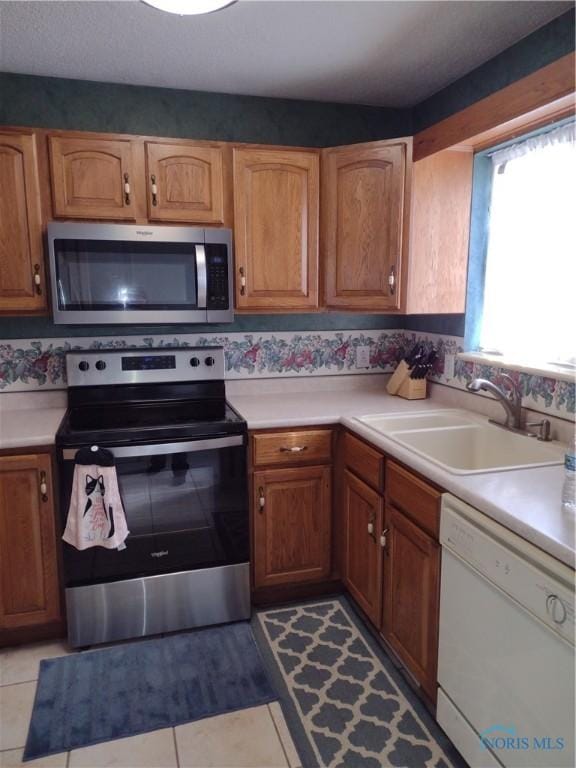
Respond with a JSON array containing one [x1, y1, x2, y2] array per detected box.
[[54, 239, 198, 311]]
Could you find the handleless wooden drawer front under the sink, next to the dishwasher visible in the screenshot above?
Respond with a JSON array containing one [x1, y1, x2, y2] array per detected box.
[[386, 461, 441, 538]]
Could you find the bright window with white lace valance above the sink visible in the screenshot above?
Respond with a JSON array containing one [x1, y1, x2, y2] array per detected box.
[[479, 121, 576, 364]]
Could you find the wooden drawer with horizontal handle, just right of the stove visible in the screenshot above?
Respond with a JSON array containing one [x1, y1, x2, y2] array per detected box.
[[253, 429, 332, 467]]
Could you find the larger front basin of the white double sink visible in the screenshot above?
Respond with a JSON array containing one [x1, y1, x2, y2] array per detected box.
[[393, 424, 564, 475]]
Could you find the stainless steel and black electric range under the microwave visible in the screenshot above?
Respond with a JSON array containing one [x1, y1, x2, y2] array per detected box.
[[56, 347, 250, 647]]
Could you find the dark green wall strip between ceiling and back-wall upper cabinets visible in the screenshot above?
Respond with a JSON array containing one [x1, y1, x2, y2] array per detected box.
[[0, 73, 412, 147]]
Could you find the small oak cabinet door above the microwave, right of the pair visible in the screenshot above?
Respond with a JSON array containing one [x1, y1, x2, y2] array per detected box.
[[146, 141, 224, 224]]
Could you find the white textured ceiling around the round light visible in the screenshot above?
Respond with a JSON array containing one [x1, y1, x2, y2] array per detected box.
[[0, 0, 572, 107]]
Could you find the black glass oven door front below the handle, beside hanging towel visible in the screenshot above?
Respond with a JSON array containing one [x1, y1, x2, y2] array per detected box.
[[65, 446, 250, 586]]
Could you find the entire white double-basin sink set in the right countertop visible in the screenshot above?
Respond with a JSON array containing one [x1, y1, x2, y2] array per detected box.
[[358, 410, 564, 475]]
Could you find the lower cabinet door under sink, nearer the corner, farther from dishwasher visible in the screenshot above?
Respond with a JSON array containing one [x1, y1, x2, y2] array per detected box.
[[343, 470, 383, 627]]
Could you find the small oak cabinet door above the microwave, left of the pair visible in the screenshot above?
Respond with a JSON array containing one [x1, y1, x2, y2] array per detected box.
[[49, 136, 142, 221]]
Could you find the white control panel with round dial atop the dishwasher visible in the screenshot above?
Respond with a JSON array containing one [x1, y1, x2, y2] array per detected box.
[[440, 496, 575, 644]]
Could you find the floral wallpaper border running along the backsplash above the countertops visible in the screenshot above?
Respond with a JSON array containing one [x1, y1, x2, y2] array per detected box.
[[0, 330, 576, 419]]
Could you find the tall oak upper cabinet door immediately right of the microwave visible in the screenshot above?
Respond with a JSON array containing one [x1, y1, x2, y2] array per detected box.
[[234, 149, 319, 311]]
